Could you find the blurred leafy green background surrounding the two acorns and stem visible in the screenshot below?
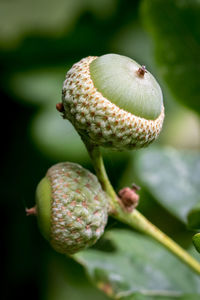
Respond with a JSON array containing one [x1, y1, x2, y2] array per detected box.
[[0, 0, 200, 300]]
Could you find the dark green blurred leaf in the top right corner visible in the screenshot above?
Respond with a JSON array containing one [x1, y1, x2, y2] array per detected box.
[[141, 0, 200, 112]]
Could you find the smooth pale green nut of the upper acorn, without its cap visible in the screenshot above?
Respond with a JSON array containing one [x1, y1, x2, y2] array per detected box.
[[90, 54, 163, 120]]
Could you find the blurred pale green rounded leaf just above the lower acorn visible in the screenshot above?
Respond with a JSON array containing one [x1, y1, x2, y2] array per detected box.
[[31, 108, 89, 163]]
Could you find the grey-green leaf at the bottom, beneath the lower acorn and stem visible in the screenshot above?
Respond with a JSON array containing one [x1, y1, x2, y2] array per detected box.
[[74, 230, 200, 299]]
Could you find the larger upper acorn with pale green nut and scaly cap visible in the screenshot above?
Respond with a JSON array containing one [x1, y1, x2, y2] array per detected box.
[[62, 54, 164, 150]]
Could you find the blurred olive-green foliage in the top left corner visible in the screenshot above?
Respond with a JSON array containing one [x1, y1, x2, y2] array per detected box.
[[0, 0, 116, 51]]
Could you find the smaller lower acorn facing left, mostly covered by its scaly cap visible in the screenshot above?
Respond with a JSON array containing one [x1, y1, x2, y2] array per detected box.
[[36, 162, 108, 254]]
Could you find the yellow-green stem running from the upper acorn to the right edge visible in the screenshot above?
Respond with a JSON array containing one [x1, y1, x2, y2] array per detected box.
[[83, 139, 200, 274]]
